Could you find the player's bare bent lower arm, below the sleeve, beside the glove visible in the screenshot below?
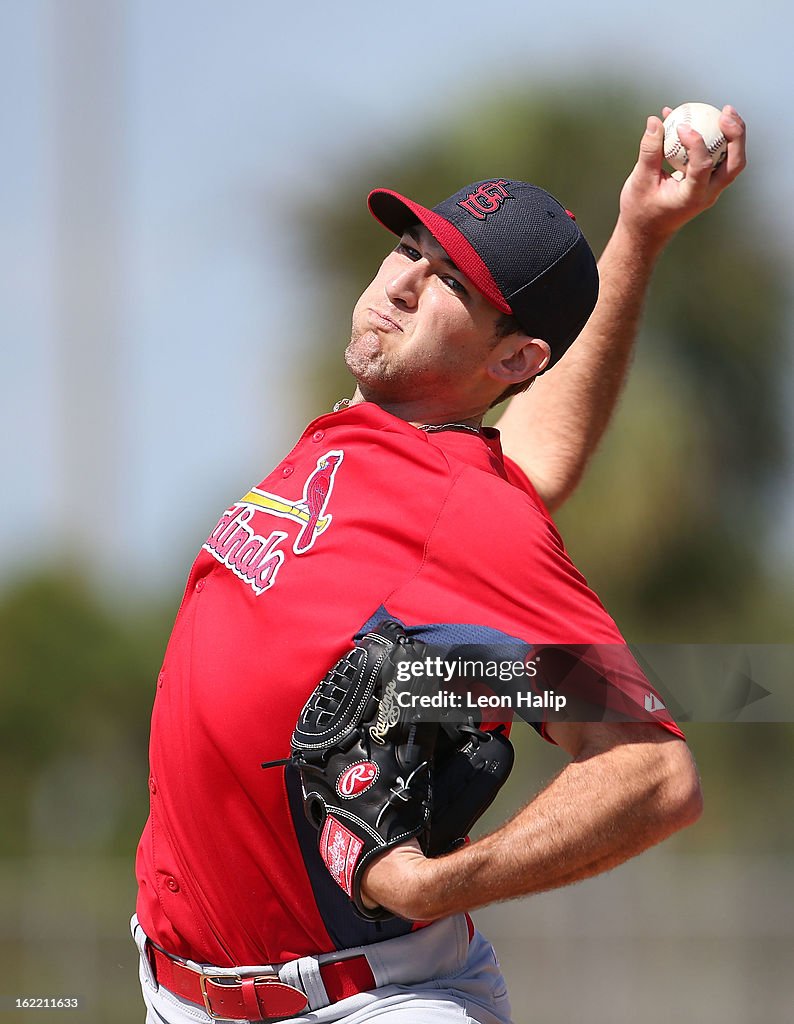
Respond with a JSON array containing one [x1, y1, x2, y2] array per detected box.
[[363, 723, 702, 921]]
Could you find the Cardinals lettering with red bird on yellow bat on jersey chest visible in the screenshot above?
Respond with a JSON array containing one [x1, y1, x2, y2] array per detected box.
[[204, 451, 344, 594]]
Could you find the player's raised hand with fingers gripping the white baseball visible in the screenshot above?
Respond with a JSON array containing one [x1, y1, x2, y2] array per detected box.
[[620, 105, 747, 245]]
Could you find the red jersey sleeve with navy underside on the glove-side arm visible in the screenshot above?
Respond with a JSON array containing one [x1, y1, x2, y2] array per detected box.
[[387, 470, 682, 738]]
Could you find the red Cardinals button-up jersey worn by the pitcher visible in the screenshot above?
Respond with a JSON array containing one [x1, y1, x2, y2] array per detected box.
[[136, 403, 680, 966]]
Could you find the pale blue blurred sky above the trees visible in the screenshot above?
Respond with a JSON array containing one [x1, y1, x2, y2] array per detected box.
[[0, 0, 794, 588]]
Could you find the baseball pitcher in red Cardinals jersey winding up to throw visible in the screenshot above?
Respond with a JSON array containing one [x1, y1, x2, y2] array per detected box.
[[132, 108, 745, 1024]]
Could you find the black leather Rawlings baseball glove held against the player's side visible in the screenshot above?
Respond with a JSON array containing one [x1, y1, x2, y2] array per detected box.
[[265, 621, 512, 921]]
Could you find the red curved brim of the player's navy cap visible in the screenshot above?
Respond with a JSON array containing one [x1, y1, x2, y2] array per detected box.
[[367, 188, 512, 313]]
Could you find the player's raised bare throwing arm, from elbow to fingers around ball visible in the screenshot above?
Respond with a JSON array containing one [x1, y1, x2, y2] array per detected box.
[[496, 106, 746, 511]]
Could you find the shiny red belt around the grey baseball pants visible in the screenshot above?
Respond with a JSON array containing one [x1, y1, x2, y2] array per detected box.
[[147, 942, 377, 1021]]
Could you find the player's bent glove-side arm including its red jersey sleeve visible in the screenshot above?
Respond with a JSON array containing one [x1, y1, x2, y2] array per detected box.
[[361, 456, 701, 920]]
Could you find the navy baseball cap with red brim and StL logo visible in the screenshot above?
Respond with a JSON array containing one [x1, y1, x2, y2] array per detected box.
[[368, 178, 598, 366]]
